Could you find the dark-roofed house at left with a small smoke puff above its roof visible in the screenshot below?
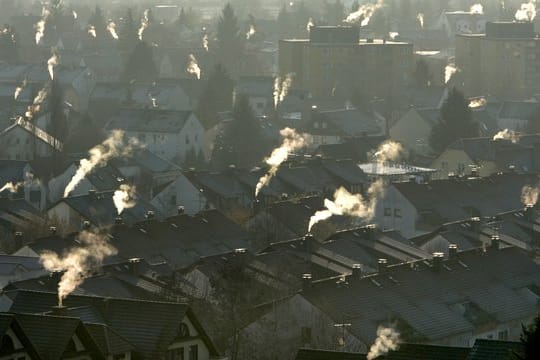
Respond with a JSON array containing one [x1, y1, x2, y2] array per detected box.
[[47, 190, 160, 233]]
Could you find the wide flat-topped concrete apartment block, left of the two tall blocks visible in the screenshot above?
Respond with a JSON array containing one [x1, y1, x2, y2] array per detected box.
[[279, 26, 414, 98]]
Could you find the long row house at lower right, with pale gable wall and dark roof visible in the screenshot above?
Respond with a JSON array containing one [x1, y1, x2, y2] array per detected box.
[[243, 247, 540, 353]]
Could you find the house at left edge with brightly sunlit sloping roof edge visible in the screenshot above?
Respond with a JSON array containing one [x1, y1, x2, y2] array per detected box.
[[0, 117, 64, 160]]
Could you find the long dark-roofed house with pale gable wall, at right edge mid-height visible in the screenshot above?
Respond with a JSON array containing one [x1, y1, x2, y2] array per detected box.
[[373, 173, 538, 238]]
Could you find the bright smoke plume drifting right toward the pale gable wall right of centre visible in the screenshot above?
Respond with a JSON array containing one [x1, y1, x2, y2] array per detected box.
[[308, 180, 384, 231]]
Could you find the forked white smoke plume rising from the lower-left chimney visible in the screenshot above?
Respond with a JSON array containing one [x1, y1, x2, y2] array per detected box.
[[39, 231, 117, 306]]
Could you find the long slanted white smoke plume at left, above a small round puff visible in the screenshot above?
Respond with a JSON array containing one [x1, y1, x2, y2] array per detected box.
[[64, 130, 139, 197]]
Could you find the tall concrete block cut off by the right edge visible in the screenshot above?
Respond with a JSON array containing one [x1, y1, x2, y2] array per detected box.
[[456, 22, 540, 99]]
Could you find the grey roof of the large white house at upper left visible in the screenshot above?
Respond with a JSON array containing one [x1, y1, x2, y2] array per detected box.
[[106, 109, 192, 133]]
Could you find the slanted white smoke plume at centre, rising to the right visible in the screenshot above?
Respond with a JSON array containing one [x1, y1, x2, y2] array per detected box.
[[255, 127, 311, 197]]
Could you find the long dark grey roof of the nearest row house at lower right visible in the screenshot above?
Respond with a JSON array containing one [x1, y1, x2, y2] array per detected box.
[[302, 248, 540, 344]]
